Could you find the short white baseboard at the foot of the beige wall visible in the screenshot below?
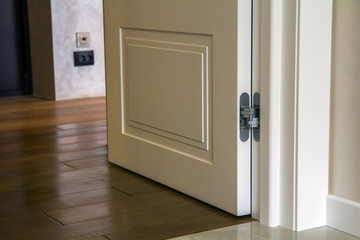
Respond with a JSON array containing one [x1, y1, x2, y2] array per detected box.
[[327, 195, 360, 237]]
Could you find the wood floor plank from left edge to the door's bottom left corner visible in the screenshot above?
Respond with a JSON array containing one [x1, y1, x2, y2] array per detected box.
[[0, 167, 148, 200]]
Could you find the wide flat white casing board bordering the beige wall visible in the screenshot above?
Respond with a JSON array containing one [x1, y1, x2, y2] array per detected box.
[[295, 0, 332, 231]]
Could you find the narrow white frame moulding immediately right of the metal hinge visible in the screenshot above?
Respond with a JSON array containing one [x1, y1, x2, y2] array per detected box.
[[260, 0, 282, 227]]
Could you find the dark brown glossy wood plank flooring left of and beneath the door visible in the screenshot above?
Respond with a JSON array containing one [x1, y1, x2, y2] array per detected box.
[[0, 97, 252, 240]]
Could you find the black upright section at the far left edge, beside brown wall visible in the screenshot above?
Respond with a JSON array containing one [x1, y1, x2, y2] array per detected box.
[[0, 0, 32, 97]]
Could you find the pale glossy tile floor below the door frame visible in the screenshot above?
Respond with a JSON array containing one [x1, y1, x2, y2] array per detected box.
[[172, 222, 360, 240]]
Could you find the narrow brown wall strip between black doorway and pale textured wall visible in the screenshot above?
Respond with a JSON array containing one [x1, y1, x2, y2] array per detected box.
[[28, 0, 55, 99]]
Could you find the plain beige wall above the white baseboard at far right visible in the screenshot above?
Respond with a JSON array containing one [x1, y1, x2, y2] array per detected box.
[[330, 0, 360, 202]]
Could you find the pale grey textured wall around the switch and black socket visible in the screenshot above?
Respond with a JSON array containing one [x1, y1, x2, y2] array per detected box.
[[51, 0, 105, 100]]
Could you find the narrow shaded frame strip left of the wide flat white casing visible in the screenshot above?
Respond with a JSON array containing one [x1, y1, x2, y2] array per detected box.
[[280, 1, 299, 229]]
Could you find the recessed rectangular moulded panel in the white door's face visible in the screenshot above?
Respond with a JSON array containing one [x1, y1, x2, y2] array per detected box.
[[121, 29, 212, 162]]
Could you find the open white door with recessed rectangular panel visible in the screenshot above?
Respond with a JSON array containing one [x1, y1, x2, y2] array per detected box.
[[104, 0, 251, 215]]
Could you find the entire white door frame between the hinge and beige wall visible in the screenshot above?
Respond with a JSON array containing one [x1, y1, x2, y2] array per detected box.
[[253, 0, 332, 231]]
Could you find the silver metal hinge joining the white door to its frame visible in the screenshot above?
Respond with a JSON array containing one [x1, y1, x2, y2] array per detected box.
[[240, 93, 260, 142]]
